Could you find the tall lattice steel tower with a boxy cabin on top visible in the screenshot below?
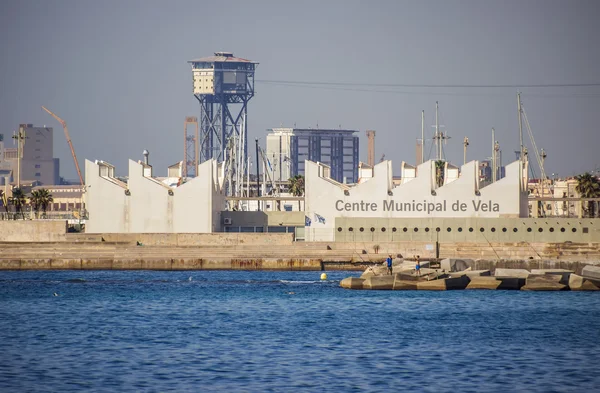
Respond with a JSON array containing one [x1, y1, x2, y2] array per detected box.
[[188, 52, 258, 163]]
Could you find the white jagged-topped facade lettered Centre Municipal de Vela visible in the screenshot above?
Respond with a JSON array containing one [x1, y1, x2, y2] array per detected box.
[[305, 161, 528, 241]]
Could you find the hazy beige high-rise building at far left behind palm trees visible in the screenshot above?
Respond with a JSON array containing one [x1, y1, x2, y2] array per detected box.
[[0, 124, 60, 185]]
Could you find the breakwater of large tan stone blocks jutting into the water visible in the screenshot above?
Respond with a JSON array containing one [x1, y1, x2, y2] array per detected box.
[[340, 259, 600, 291]]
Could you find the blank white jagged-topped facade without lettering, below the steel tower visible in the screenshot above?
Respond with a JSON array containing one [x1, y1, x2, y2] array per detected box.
[[85, 160, 225, 233]]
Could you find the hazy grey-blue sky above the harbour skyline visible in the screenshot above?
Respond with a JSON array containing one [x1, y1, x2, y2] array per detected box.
[[0, 0, 600, 179]]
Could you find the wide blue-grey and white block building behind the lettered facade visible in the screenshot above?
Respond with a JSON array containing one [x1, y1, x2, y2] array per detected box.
[[267, 128, 358, 183]]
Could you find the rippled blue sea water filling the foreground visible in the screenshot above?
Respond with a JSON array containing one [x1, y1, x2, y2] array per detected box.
[[0, 271, 600, 392]]
